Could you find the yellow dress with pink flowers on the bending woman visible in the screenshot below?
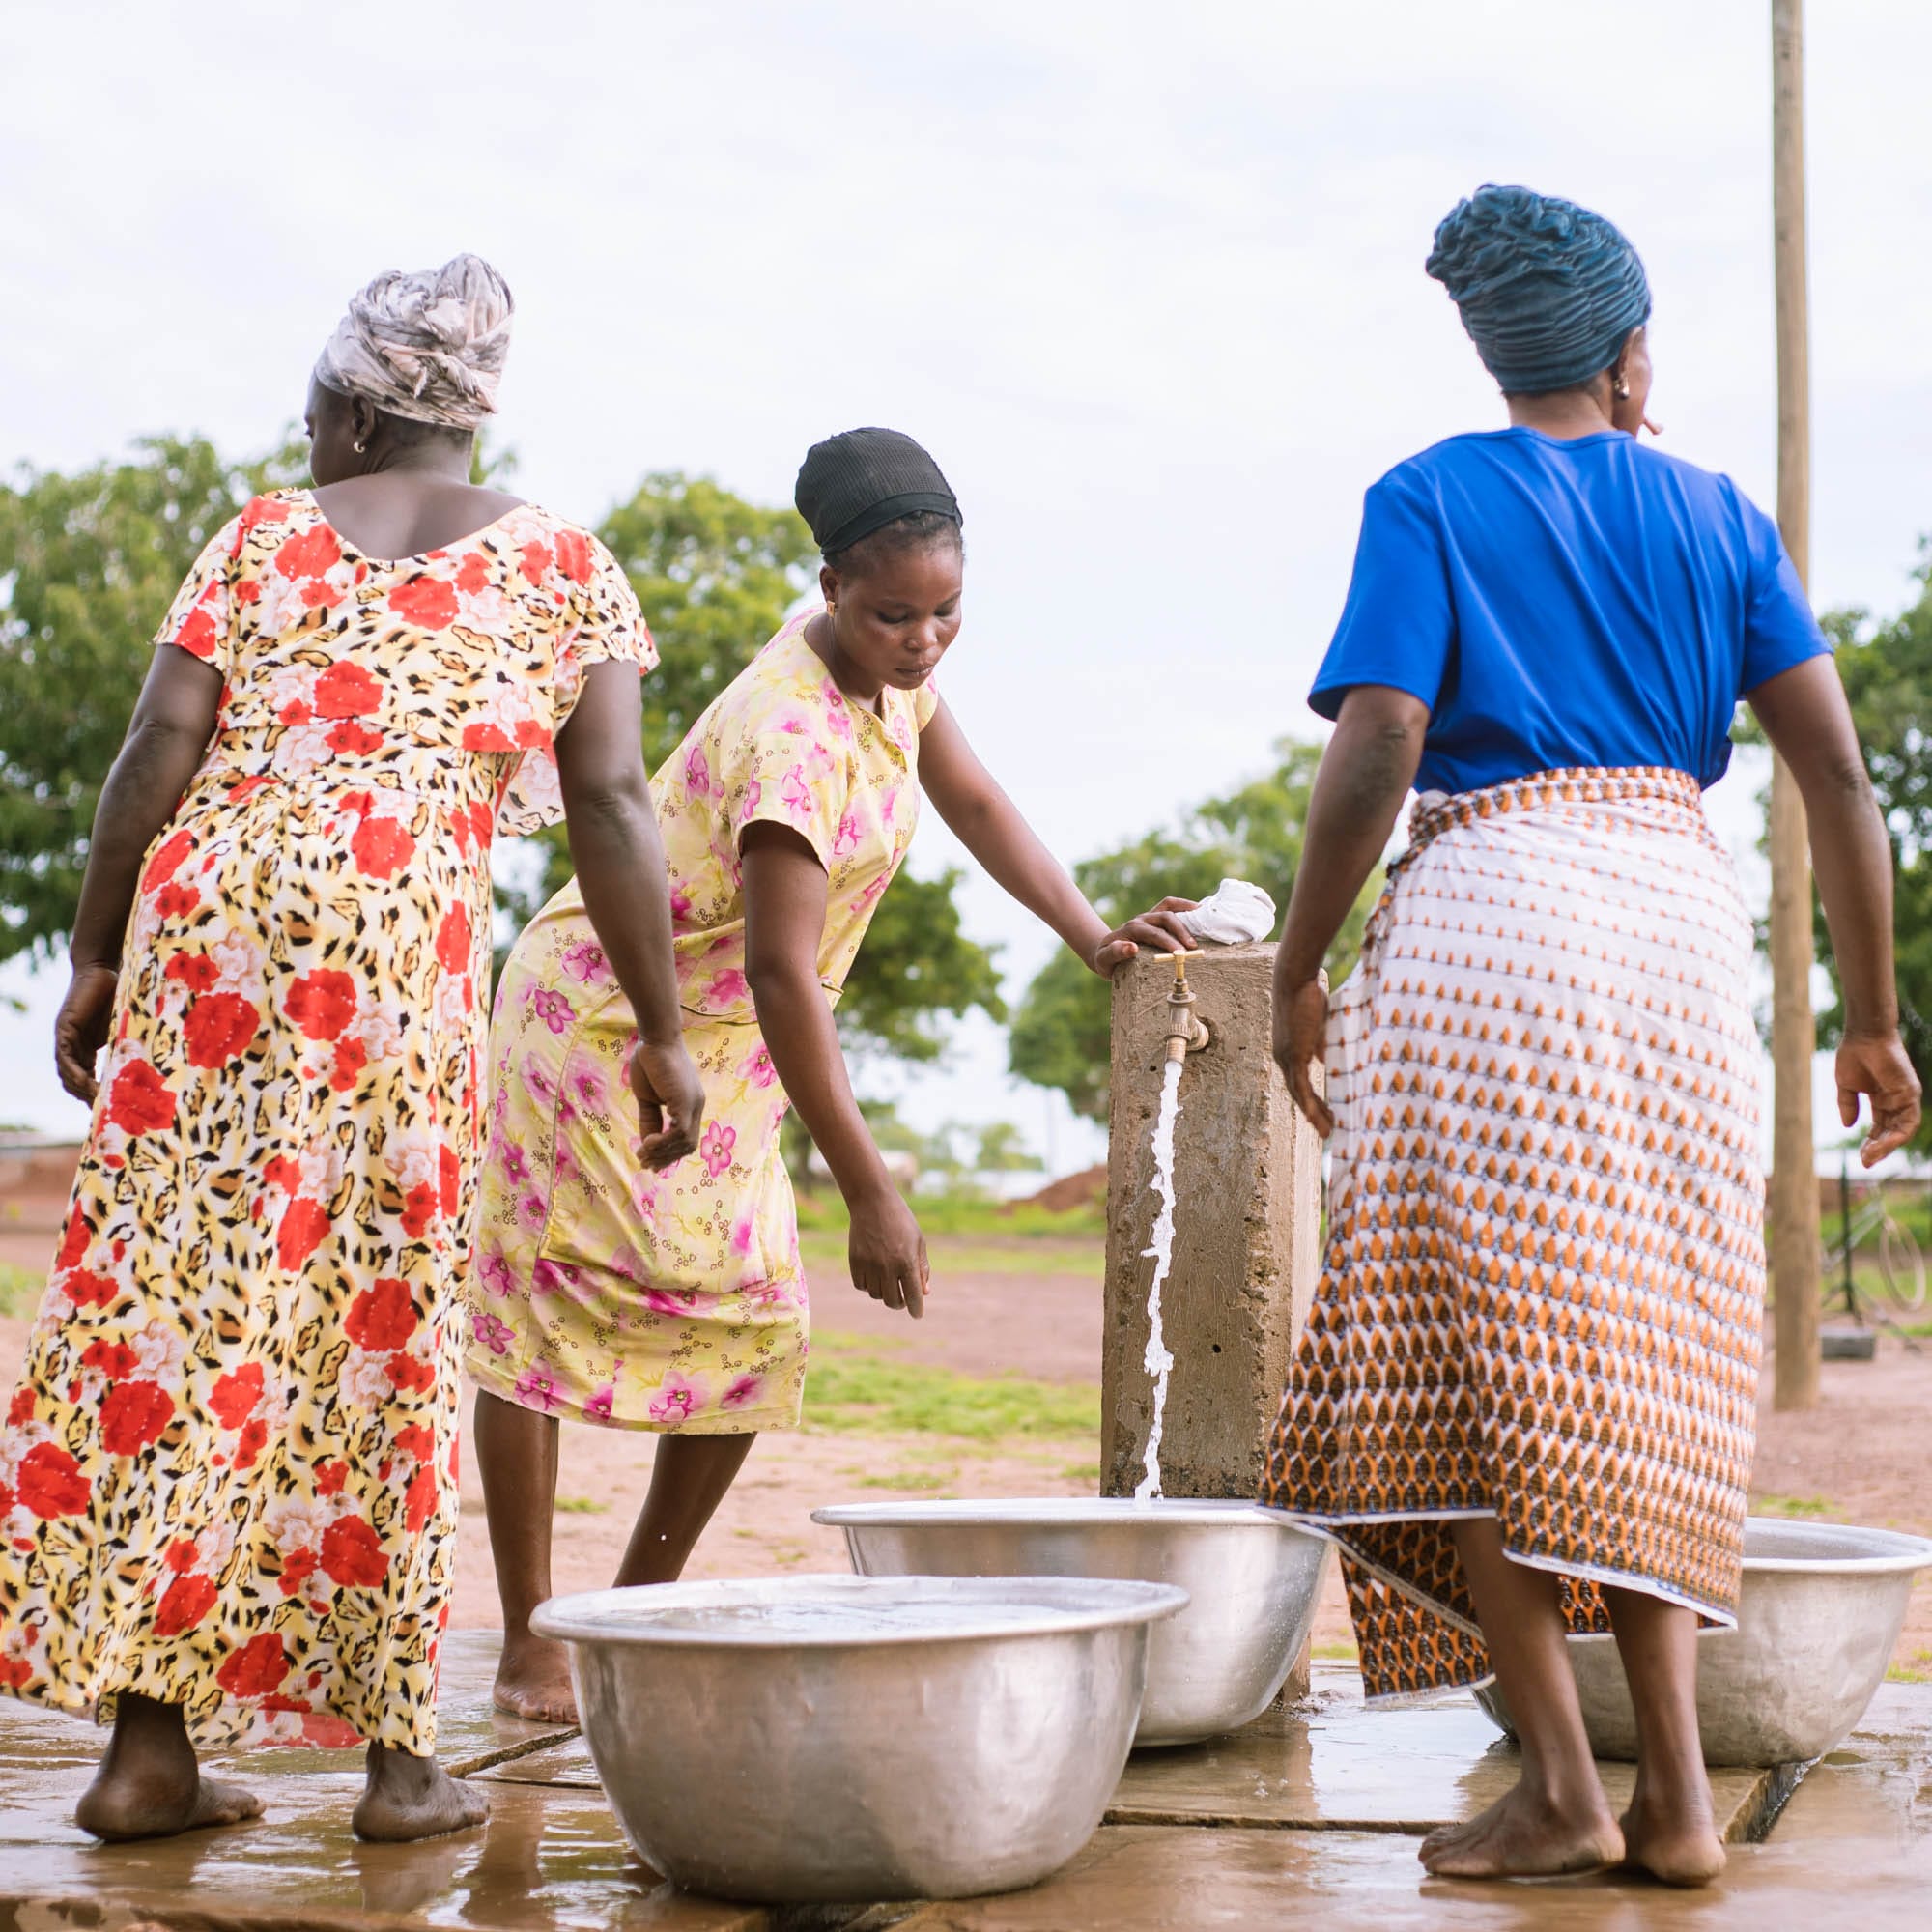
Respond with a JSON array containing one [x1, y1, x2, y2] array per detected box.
[[469, 612, 939, 1435]]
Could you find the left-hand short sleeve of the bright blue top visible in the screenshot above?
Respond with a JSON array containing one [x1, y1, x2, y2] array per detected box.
[[1308, 471, 1455, 719]]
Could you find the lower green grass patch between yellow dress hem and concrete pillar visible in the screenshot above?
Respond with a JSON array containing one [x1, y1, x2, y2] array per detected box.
[[806, 1331, 1099, 1443]]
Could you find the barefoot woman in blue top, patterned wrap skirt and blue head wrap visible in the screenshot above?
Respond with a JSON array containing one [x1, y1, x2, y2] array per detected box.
[[1264, 187, 1918, 1884]]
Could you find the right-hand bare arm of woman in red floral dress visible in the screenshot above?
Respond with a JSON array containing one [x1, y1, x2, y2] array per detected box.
[[556, 663, 705, 1167]]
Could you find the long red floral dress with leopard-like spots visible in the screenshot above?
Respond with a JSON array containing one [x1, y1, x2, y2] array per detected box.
[[0, 491, 655, 1754]]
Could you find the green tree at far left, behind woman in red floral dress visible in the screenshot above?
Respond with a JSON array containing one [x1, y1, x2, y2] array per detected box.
[[0, 437, 305, 958]]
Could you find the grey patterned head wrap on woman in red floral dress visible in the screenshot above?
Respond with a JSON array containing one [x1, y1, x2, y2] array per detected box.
[[315, 255, 516, 429]]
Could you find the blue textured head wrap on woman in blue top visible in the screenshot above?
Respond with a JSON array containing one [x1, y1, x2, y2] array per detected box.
[[1426, 182, 1650, 396]]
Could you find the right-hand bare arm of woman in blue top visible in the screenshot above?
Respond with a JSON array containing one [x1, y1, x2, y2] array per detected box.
[[1747, 657, 1920, 1167]]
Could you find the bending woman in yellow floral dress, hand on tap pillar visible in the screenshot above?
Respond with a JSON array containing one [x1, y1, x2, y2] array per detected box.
[[469, 429, 1186, 1718]]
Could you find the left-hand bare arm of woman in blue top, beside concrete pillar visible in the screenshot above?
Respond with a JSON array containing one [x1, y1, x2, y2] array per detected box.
[[1275, 684, 1430, 1136]]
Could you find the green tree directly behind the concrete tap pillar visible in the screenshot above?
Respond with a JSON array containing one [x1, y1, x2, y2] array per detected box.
[[1009, 738, 1379, 1121]]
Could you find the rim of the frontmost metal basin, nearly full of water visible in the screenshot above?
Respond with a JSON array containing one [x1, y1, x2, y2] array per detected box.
[[529, 1571, 1188, 1652]]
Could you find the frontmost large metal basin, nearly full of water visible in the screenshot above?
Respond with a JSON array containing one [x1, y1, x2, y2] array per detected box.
[[531, 1577, 1186, 1903]]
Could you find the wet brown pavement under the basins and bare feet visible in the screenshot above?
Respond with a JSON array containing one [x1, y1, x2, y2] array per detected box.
[[0, 1633, 1932, 1932]]
